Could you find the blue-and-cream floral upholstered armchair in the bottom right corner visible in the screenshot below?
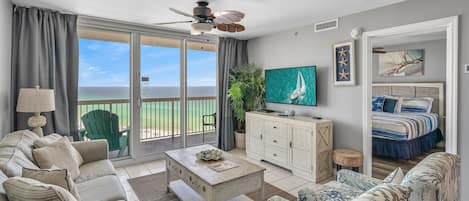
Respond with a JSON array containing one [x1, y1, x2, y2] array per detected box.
[[298, 152, 460, 201]]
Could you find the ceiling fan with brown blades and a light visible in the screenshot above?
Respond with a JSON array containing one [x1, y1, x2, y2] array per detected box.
[[154, 0, 245, 35]]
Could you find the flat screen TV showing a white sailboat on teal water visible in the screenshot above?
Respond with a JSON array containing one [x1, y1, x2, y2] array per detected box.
[[265, 66, 317, 106]]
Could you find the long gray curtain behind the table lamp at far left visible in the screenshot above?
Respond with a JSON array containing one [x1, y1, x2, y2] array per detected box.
[[12, 6, 78, 137]]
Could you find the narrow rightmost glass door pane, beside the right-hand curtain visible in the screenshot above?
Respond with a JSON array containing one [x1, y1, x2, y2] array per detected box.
[[186, 41, 217, 146]]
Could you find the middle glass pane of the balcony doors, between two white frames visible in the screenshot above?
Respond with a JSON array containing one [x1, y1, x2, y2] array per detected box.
[[139, 36, 182, 155]]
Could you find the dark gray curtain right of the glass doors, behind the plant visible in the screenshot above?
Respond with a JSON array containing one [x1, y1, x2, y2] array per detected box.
[[218, 38, 249, 151]]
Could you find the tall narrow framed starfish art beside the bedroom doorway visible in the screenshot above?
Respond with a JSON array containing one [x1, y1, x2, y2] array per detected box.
[[333, 41, 355, 85]]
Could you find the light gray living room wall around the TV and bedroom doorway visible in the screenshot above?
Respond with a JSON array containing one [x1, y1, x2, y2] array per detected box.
[[248, 0, 469, 200]]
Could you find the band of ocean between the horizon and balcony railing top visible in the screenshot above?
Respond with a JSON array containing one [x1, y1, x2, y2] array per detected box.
[[78, 86, 216, 101]]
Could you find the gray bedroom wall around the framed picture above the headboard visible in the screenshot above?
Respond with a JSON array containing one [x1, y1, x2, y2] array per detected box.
[[373, 40, 446, 82]]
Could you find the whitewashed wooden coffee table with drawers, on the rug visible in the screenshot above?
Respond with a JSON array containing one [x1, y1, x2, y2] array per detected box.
[[165, 145, 265, 201]]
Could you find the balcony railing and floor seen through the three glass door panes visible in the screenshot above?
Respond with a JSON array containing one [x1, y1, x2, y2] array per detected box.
[[78, 96, 216, 156]]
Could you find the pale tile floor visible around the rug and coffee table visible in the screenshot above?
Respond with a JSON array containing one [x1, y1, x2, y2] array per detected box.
[[117, 149, 332, 201]]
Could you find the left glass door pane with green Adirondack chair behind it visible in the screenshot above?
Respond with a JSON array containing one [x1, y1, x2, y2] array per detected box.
[[78, 29, 131, 158]]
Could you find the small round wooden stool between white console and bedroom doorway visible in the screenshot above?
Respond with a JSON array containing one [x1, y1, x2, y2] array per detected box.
[[332, 149, 363, 172]]
